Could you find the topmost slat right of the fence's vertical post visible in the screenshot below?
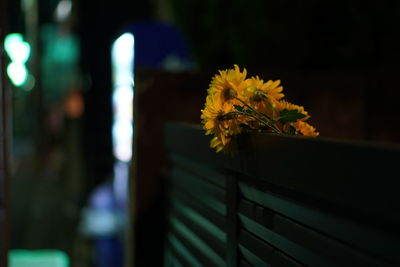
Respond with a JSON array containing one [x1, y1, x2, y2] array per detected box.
[[239, 182, 400, 263]]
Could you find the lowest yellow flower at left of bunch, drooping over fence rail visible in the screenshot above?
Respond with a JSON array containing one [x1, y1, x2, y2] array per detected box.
[[201, 95, 241, 150]]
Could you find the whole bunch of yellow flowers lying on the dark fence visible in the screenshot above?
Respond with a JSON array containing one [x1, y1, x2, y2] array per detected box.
[[201, 65, 318, 152]]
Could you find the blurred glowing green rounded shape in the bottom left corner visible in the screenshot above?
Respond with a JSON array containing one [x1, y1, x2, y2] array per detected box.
[[8, 249, 69, 267]]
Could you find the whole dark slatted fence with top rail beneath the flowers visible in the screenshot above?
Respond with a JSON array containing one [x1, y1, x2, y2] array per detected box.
[[162, 125, 400, 267]]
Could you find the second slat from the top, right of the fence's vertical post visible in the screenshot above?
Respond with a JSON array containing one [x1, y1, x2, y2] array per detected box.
[[239, 199, 385, 266]]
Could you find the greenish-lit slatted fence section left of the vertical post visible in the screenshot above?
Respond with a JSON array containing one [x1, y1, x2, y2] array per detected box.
[[166, 155, 227, 266]]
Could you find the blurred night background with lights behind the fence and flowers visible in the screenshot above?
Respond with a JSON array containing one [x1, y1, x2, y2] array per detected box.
[[0, 0, 400, 267]]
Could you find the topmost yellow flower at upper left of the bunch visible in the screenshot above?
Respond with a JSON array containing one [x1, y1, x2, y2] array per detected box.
[[208, 65, 247, 103]]
